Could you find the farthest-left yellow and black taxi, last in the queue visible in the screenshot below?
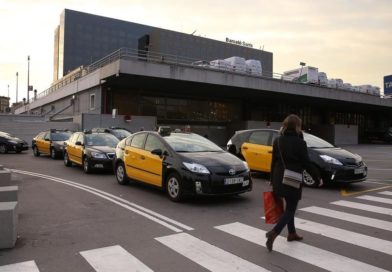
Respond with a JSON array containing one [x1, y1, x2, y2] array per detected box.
[[31, 129, 72, 159]]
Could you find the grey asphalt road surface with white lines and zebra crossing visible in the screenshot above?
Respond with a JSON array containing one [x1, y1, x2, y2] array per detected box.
[[0, 145, 392, 272]]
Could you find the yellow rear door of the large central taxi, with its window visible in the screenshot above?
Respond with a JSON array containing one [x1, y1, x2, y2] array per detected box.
[[124, 133, 147, 181]]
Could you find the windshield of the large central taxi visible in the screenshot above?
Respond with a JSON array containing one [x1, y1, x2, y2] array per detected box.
[[164, 133, 223, 152]]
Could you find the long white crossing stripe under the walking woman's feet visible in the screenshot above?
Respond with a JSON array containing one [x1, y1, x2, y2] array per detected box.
[[215, 222, 387, 272]]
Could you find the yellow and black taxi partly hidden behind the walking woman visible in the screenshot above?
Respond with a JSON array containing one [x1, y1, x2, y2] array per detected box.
[[227, 129, 367, 187]]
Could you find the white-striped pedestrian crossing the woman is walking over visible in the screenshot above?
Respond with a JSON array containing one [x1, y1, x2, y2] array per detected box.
[[0, 191, 392, 272]]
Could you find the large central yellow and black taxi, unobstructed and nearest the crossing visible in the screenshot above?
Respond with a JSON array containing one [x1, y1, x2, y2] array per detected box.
[[114, 131, 252, 201]]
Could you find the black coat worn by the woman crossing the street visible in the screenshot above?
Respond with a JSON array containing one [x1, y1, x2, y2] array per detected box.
[[271, 130, 320, 199]]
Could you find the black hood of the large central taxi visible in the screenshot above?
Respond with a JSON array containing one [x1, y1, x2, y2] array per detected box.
[[178, 152, 244, 167]]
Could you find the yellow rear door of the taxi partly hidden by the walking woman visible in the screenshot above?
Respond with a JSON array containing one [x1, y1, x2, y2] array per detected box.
[[241, 130, 272, 173]]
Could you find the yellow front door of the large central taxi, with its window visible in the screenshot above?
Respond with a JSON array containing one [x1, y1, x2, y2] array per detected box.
[[140, 134, 166, 187]]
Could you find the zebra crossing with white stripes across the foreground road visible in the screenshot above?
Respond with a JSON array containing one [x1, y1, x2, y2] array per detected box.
[[0, 191, 392, 272]]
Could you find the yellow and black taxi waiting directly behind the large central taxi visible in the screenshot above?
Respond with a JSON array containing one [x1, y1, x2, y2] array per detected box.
[[64, 131, 119, 173]]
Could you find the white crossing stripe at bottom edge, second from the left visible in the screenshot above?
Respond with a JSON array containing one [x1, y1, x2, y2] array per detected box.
[[80, 245, 153, 272]]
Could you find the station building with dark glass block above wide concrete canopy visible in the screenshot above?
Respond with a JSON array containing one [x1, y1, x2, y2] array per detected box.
[[16, 9, 392, 145]]
